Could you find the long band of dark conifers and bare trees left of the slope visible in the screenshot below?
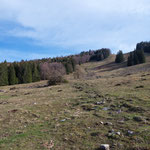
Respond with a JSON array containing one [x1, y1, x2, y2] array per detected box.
[[0, 49, 110, 86]]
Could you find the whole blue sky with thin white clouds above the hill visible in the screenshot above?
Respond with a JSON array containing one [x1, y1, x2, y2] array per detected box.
[[0, 0, 150, 61]]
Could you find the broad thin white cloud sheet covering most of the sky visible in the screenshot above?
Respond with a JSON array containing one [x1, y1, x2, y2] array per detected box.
[[0, 0, 150, 51]]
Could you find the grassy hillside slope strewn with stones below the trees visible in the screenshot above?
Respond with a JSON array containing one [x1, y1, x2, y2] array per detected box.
[[0, 55, 150, 150]]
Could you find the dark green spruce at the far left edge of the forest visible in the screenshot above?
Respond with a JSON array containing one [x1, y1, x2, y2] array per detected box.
[[0, 62, 8, 86]]
